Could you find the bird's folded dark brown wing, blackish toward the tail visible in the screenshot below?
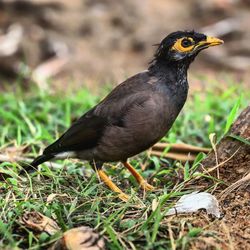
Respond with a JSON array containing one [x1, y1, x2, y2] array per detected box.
[[44, 72, 150, 154]]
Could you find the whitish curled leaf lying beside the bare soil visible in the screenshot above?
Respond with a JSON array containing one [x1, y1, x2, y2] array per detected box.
[[167, 192, 220, 218]]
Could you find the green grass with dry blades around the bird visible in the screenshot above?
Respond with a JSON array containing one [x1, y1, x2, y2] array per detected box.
[[0, 78, 250, 250]]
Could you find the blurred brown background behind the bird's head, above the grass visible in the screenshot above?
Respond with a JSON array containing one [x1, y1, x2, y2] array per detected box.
[[0, 0, 250, 91]]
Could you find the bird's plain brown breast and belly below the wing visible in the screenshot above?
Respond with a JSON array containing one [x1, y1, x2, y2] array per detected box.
[[93, 92, 185, 161]]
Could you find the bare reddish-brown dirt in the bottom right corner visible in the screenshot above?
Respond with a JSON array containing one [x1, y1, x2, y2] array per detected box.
[[187, 183, 250, 250]]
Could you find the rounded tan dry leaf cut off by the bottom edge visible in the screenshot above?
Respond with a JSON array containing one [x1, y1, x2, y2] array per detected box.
[[50, 227, 106, 250]]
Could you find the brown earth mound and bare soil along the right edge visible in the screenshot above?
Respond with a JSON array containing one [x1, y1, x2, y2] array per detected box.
[[188, 106, 250, 249]]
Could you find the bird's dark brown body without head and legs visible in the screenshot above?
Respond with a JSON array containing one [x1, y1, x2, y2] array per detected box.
[[37, 65, 188, 165]]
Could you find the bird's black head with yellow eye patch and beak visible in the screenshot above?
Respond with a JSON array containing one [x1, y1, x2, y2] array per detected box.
[[155, 31, 223, 62]]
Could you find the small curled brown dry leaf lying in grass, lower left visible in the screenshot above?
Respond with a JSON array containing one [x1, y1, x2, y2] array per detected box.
[[21, 211, 60, 235]]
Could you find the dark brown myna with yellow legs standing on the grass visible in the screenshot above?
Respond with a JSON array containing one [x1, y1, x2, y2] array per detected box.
[[30, 31, 223, 202]]
